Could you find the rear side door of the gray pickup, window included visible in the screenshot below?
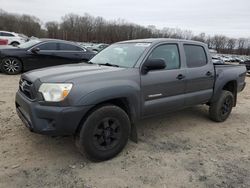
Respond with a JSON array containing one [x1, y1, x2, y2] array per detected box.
[[183, 43, 214, 106]]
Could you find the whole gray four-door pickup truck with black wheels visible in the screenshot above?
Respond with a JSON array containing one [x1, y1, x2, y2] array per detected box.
[[16, 39, 246, 161]]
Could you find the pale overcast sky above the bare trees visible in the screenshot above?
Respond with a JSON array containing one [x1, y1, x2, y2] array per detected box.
[[0, 0, 250, 38]]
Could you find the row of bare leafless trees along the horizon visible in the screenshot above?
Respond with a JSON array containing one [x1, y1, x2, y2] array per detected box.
[[0, 10, 250, 55]]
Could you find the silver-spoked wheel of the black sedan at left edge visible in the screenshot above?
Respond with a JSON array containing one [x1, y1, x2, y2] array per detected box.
[[0, 57, 22, 75]]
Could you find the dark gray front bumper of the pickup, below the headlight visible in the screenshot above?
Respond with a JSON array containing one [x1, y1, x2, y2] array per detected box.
[[16, 91, 92, 136]]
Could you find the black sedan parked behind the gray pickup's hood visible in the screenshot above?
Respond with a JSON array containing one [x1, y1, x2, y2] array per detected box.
[[0, 39, 95, 75]]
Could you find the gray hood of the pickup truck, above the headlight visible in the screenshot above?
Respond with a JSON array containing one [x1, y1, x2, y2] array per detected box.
[[22, 63, 125, 83]]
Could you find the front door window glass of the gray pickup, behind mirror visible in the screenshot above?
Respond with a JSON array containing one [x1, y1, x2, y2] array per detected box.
[[149, 44, 180, 70]]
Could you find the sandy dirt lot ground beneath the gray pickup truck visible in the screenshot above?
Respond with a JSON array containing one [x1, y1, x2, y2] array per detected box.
[[0, 74, 250, 188]]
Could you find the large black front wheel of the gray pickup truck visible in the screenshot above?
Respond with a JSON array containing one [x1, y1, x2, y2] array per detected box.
[[76, 105, 130, 161]]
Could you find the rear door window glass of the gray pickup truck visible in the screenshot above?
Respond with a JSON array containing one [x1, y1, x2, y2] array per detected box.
[[184, 44, 207, 68]]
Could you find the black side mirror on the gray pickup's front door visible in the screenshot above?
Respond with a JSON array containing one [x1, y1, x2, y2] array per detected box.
[[142, 59, 166, 74]]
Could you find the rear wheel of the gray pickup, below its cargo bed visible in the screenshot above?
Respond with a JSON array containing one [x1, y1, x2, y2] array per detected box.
[[209, 90, 234, 122]]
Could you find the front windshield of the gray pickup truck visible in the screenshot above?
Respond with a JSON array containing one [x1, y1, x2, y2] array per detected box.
[[91, 43, 151, 68]]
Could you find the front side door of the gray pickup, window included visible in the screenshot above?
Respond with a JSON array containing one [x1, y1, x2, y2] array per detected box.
[[141, 43, 186, 117]]
